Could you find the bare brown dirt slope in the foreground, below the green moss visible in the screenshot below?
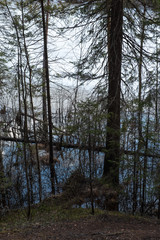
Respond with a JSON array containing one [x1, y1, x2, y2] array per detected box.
[[0, 214, 160, 240]]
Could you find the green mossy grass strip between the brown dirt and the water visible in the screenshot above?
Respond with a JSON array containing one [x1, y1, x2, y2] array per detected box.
[[0, 197, 102, 232]]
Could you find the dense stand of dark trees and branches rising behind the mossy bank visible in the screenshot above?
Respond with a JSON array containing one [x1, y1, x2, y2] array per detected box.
[[0, 0, 160, 218]]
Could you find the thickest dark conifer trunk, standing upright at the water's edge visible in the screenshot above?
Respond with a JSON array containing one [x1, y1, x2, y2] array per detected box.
[[103, 0, 123, 195]]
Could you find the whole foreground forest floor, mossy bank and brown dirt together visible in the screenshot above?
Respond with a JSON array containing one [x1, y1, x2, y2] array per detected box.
[[0, 196, 160, 240]]
